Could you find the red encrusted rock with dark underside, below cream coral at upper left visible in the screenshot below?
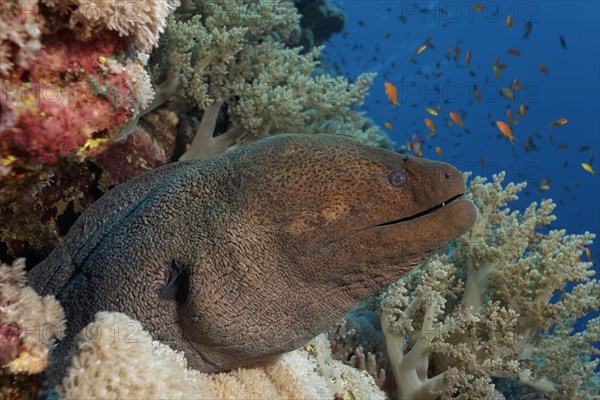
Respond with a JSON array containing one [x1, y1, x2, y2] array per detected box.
[[0, 23, 172, 256]]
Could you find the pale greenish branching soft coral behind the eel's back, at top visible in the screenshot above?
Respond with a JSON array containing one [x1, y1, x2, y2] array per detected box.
[[142, 0, 391, 160]]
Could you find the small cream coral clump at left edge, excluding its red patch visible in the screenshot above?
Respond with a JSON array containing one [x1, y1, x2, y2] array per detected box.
[[0, 258, 65, 374]]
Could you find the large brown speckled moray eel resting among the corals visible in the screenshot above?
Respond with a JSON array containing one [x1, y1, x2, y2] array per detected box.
[[28, 134, 476, 383]]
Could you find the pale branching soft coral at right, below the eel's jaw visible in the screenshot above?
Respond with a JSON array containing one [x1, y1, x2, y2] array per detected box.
[[381, 173, 600, 399]]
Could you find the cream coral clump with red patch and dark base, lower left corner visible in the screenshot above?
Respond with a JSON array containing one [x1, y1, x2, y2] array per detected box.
[[0, 258, 65, 398]]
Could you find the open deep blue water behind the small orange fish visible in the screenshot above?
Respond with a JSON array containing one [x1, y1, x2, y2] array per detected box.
[[325, 0, 600, 334]]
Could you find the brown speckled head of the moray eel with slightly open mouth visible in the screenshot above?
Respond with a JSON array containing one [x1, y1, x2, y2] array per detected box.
[[242, 135, 476, 268]]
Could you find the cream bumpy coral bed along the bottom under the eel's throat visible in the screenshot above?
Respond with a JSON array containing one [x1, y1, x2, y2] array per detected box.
[[57, 312, 384, 400]]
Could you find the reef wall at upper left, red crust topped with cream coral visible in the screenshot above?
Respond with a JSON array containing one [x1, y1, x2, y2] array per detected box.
[[0, 0, 178, 258]]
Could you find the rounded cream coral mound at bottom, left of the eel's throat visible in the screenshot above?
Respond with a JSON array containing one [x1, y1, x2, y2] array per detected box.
[[57, 312, 211, 399]]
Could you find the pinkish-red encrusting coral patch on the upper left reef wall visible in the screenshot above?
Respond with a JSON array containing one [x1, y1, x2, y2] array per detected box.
[[0, 33, 140, 165]]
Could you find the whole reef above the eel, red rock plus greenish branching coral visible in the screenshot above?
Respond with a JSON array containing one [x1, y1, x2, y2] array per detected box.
[[0, 0, 393, 261]]
